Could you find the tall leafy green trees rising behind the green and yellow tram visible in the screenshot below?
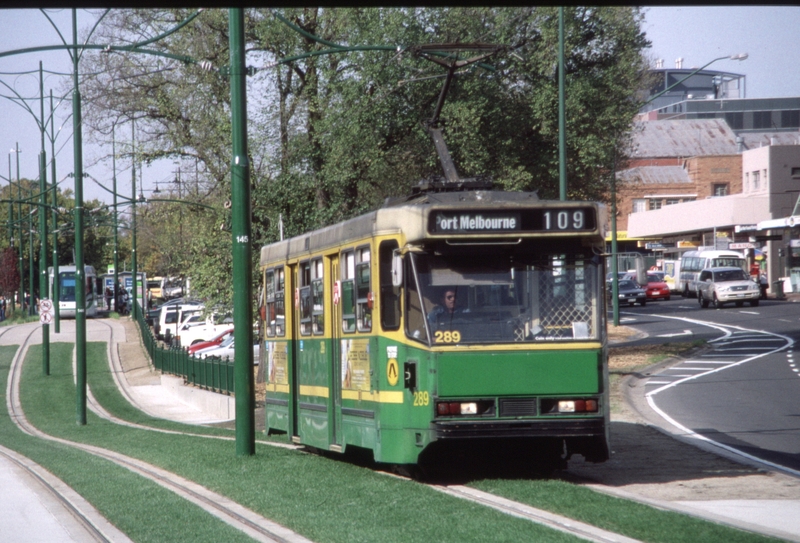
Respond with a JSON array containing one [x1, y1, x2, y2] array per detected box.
[[76, 6, 649, 312]]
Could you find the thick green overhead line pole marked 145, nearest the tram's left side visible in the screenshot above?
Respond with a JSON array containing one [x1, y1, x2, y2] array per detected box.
[[228, 8, 255, 456]]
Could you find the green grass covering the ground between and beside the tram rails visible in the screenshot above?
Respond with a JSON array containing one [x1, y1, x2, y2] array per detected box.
[[0, 343, 772, 543]]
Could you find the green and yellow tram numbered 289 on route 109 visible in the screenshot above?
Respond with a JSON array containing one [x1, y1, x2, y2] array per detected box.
[[261, 190, 609, 470]]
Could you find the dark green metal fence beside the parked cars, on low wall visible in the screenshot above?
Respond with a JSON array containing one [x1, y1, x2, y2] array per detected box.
[[136, 302, 234, 394]]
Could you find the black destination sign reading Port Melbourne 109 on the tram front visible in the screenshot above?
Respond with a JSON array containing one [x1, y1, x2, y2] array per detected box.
[[428, 206, 597, 234]]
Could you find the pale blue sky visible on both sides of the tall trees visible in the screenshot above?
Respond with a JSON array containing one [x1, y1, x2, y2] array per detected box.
[[0, 6, 800, 200]]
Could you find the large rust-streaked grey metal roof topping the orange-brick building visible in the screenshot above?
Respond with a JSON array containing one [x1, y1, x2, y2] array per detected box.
[[630, 119, 738, 158]]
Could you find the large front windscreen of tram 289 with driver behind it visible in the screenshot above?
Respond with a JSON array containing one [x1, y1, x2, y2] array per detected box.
[[406, 253, 603, 345]]
